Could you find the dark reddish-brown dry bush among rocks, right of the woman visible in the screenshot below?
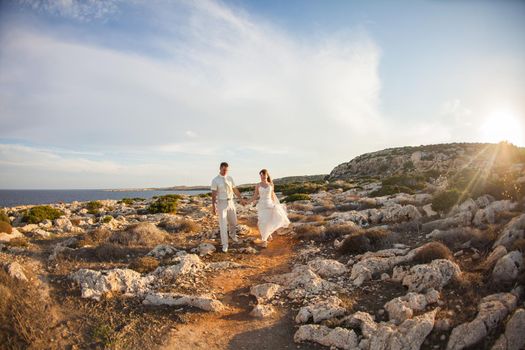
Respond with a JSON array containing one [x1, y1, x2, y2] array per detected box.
[[338, 228, 393, 254]]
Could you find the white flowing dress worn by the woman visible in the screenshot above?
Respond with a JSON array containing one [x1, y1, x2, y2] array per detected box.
[[257, 185, 290, 241]]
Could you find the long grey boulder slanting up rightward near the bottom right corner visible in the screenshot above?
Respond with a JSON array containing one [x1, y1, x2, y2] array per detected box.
[[447, 293, 518, 350]]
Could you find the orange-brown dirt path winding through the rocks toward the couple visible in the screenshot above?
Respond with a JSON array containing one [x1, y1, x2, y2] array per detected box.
[[164, 236, 319, 350]]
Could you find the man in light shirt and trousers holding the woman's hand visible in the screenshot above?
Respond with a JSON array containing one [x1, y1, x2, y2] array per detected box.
[[211, 162, 246, 253]]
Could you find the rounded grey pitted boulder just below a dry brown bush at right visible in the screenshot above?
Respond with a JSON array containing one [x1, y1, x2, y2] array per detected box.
[[403, 259, 461, 292]]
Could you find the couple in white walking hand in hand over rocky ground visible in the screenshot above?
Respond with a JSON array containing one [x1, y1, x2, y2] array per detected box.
[[211, 162, 290, 253]]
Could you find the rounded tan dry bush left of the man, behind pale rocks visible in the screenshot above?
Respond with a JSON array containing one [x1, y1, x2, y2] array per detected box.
[[109, 222, 168, 246]]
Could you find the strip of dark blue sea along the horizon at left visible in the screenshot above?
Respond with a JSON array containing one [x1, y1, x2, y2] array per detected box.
[[0, 190, 209, 207]]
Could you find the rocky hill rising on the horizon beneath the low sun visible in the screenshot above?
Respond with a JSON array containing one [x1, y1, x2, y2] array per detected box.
[[329, 143, 525, 180]]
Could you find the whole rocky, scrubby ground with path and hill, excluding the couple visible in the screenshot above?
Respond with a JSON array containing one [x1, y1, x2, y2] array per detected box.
[[0, 144, 525, 349]]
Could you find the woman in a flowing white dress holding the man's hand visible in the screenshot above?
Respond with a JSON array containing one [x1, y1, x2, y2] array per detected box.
[[251, 169, 290, 247]]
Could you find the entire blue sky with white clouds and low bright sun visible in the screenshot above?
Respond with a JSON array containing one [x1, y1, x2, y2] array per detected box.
[[0, 0, 525, 189]]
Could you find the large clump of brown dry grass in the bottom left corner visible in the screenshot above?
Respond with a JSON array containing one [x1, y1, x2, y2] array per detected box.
[[0, 269, 53, 349]]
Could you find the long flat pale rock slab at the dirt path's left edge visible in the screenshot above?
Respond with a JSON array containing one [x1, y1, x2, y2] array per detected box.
[[142, 292, 224, 312]]
